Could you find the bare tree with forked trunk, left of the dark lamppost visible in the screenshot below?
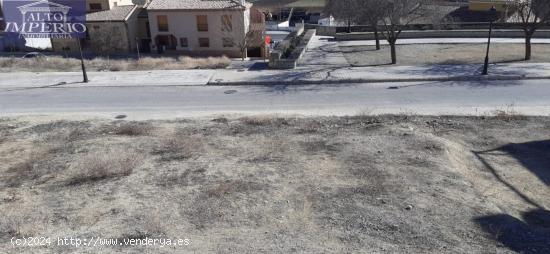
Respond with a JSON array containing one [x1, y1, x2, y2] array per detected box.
[[381, 0, 433, 64]]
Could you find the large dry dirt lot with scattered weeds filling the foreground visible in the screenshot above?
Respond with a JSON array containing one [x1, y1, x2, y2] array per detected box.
[[0, 113, 550, 253]]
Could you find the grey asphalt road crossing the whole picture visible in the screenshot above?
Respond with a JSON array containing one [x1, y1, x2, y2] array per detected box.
[[0, 80, 550, 119]]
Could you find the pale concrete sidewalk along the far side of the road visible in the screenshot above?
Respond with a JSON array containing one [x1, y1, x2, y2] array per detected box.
[[0, 63, 550, 91]]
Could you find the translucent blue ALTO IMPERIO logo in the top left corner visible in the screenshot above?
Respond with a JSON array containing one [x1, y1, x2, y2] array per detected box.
[[0, 0, 86, 38]]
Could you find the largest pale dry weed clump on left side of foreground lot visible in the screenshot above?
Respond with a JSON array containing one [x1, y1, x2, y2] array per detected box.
[[66, 150, 144, 185]]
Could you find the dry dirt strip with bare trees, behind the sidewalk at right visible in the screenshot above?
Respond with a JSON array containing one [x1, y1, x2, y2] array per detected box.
[[340, 43, 550, 66]]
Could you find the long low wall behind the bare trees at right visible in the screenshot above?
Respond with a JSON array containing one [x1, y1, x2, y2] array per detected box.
[[334, 30, 550, 41]]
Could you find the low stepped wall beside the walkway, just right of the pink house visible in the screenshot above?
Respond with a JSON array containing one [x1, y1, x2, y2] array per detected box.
[[269, 29, 316, 69]]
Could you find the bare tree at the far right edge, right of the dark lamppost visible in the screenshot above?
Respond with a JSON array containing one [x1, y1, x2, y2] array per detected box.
[[513, 0, 550, 60]]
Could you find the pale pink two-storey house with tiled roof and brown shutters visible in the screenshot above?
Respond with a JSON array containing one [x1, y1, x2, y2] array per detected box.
[[147, 0, 265, 57]]
